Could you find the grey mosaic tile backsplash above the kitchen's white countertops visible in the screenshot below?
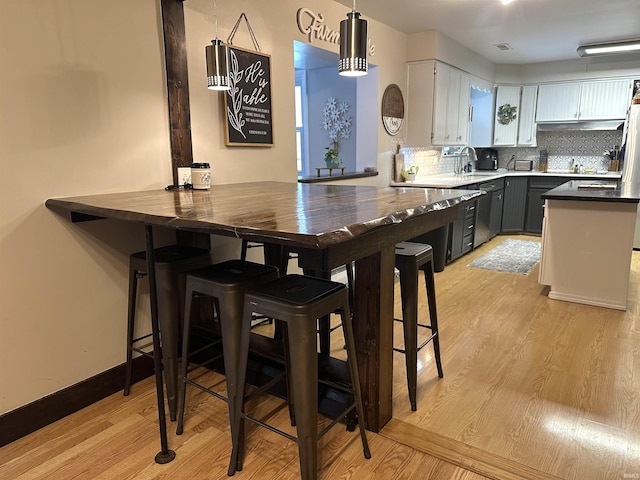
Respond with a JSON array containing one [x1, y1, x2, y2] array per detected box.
[[402, 130, 622, 176]]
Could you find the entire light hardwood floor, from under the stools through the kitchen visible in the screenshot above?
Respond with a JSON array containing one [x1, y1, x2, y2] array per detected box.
[[0, 236, 640, 480]]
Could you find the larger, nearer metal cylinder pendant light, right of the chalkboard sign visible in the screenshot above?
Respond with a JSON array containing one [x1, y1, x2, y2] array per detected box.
[[338, 0, 368, 77]]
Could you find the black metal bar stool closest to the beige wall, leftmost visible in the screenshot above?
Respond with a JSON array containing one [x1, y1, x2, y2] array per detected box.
[[124, 245, 211, 419]]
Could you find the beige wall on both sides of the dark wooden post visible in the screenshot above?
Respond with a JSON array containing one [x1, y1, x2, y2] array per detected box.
[[0, 0, 406, 414]]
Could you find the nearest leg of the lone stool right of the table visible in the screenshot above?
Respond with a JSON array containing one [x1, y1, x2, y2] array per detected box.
[[399, 263, 418, 411]]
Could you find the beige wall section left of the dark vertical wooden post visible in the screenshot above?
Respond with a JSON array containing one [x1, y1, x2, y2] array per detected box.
[[0, 0, 178, 413]]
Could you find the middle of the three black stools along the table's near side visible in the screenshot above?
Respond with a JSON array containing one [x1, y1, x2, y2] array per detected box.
[[176, 260, 284, 464]]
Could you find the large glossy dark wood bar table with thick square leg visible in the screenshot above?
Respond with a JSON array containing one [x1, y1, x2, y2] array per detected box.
[[46, 182, 483, 454]]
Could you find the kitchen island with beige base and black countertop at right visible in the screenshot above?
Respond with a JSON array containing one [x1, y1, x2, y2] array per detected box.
[[539, 180, 640, 310]]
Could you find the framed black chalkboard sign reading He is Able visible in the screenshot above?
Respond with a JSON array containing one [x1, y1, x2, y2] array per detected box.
[[224, 46, 273, 147]]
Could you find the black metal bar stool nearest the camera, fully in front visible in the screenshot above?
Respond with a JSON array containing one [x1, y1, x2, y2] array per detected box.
[[229, 275, 371, 480]]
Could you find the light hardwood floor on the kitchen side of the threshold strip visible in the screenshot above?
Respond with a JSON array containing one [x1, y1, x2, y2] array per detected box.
[[382, 236, 640, 480]]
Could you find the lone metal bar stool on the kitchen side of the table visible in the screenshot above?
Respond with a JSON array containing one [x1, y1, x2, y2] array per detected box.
[[394, 242, 442, 411]]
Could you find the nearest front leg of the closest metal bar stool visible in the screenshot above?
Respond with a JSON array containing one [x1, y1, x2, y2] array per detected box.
[[285, 319, 318, 480]]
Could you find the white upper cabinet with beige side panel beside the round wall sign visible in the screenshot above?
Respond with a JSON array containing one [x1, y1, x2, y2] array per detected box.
[[407, 62, 471, 146]]
